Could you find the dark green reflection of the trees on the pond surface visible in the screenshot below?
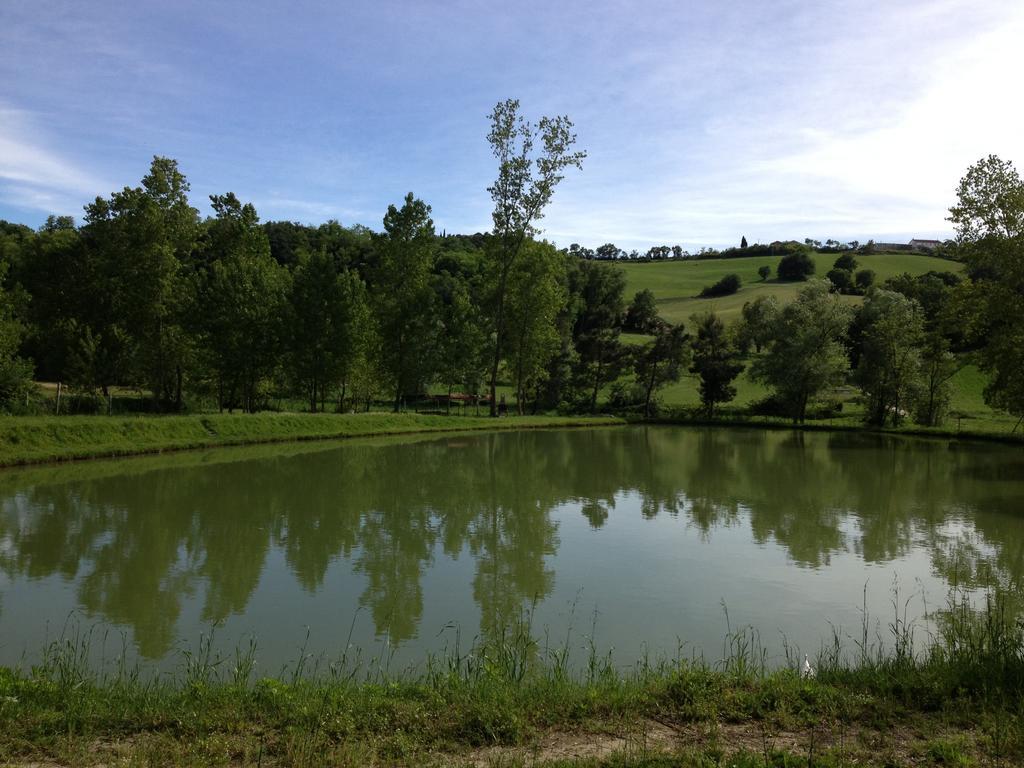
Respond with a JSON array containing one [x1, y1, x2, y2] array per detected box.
[[0, 428, 1024, 658]]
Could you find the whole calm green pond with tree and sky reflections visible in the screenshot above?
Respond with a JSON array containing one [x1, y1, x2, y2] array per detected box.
[[0, 427, 1024, 672]]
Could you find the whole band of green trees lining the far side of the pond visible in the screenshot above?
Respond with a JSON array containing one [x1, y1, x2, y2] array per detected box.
[[0, 110, 1024, 425]]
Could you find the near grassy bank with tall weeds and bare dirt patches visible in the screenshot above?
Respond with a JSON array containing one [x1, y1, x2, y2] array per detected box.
[[0, 600, 1024, 768]]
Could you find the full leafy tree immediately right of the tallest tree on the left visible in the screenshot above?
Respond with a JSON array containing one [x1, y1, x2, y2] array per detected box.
[[194, 193, 290, 413]]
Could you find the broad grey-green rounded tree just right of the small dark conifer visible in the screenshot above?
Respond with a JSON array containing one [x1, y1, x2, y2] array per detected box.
[[751, 280, 851, 423]]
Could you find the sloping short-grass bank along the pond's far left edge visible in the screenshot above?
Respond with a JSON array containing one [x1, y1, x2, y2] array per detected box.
[[0, 413, 622, 466]]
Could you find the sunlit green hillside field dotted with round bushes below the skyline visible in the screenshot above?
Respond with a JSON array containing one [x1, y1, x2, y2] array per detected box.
[[622, 253, 963, 324]]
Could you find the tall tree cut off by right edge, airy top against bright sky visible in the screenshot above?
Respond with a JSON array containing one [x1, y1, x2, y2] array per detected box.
[[949, 155, 1024, 420]]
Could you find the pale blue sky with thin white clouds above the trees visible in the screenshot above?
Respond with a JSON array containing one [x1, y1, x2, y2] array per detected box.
[[0, 0, 1024, 251]]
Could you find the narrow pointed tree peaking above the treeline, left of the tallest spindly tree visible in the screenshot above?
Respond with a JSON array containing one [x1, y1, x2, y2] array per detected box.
[[373, 193, 437, 413]]
